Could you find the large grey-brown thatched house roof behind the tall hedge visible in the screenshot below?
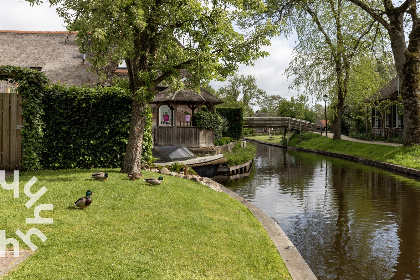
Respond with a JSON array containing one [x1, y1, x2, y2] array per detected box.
[[0, 30, 99, 86]]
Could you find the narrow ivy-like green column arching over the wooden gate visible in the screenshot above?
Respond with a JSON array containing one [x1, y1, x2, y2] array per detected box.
[[0, 65, 48, 170]]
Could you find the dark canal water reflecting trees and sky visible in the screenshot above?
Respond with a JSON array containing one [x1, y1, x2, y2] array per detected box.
[[225, 144, 420, 279]]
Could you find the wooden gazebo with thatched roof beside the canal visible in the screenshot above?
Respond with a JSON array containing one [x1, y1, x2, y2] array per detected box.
[[152, 88, 223, 148]]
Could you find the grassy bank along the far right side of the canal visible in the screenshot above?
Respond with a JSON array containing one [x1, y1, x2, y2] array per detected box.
[[249, 133, 420, 169]]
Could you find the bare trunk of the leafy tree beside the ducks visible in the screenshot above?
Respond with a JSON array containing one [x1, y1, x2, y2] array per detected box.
[[121, 99, 149, 173]]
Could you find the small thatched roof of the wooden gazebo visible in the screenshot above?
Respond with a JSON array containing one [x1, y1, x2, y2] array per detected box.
[[152, 88, 223, 105]]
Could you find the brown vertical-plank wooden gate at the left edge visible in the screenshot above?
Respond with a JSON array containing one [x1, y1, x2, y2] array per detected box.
[[0, 92, 23, 170]]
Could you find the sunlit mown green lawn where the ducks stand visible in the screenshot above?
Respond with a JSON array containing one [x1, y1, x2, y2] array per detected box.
[[0, 170, 290, 279]]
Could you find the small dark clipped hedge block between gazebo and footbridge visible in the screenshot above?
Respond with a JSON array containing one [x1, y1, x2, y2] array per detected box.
[[216, 108, 244, 140]]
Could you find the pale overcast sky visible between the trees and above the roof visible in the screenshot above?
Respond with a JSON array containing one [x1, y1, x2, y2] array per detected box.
[[0, 0, 297, 99]]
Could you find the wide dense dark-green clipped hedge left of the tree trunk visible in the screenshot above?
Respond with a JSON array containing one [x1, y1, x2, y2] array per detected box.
[[42, 85, 132, 169]]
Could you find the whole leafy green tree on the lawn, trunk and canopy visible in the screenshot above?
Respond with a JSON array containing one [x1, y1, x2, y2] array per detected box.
[[27, 0, 277, 173]]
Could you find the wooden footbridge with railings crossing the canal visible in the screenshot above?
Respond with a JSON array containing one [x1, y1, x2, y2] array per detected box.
[[243, 117, 323, 143]]
